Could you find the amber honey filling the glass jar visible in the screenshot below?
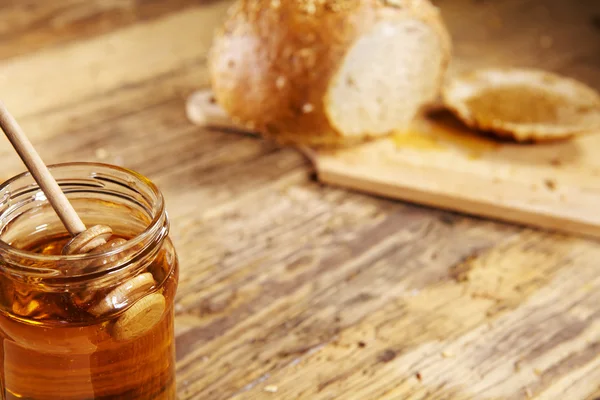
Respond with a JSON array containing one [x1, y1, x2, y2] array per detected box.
[[0, 236, 178, 400]]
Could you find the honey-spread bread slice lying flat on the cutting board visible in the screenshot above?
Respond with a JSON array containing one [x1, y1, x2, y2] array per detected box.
[[443, 68, 600, 142]]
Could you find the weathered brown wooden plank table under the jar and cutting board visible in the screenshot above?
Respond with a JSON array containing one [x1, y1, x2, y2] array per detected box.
[[0, 0, 600, 400]]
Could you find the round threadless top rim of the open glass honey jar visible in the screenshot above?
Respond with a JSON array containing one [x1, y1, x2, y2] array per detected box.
[[0, 161, 166, 262]]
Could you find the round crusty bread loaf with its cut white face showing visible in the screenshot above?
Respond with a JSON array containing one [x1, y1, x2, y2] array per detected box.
[[209, 0, 451, 146]]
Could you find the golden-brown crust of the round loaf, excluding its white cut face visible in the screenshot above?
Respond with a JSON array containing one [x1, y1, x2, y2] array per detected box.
[[209, 0, 451, 146]]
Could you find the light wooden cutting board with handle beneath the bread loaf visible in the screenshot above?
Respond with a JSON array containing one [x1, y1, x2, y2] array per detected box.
[[187, 91, 600, 238]]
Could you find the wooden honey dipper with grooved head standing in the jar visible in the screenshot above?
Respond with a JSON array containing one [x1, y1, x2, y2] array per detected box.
[[0, 101, 166, 340]]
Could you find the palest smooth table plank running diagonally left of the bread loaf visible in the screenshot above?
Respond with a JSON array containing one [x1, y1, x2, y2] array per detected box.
[[0, 2, 228, 118]]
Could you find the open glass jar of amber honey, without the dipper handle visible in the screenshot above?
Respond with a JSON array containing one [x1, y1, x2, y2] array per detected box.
[[0, 163, 178, 400]]
